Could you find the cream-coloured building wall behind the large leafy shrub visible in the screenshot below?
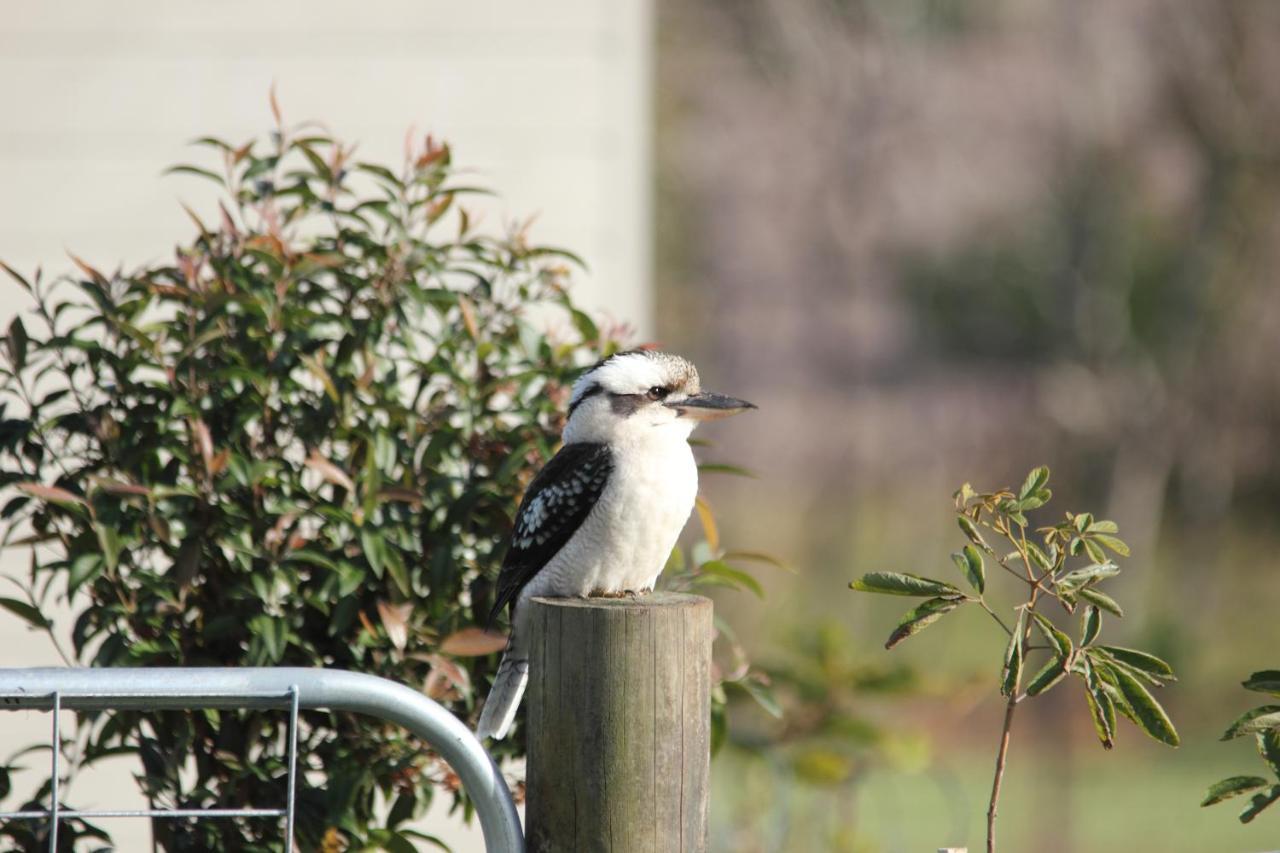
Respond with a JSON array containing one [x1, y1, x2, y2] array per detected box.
[[0, 0, 650, 850]]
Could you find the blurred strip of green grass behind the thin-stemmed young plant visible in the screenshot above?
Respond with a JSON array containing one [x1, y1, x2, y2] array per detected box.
[[712, 738, 1280, 853]]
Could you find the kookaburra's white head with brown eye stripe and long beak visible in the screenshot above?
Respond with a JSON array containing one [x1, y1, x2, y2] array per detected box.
[[564, 350, 755, 443]]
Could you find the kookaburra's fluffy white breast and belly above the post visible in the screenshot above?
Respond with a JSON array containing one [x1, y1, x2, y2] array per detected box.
[[517, 429, 698, 604]]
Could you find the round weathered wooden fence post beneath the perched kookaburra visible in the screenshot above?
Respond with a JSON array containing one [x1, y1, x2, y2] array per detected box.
[[525, 592, 712, 853]]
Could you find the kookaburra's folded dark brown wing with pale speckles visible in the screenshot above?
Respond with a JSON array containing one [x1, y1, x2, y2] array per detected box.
[[489, 442, 613, 621]]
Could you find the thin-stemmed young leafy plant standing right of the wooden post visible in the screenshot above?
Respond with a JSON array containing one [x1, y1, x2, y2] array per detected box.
[[850, 466, 1179, 852]]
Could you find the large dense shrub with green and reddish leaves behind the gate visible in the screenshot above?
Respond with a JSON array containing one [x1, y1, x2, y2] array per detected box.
[[0, 109, 757, 850]]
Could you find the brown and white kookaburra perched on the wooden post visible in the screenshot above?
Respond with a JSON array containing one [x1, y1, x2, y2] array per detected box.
[[476, 351, 755, 738]]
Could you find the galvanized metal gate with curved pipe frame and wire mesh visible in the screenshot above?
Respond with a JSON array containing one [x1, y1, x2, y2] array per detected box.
[[0, 667, 525, 853]]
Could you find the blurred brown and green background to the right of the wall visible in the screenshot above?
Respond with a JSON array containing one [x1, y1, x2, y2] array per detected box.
[[657, 0, 1280, 852]]
